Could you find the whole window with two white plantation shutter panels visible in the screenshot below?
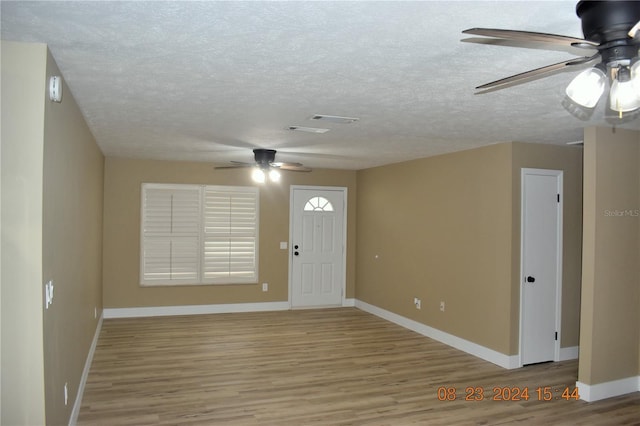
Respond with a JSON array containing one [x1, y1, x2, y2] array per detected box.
[[140, 183, 258, 286]]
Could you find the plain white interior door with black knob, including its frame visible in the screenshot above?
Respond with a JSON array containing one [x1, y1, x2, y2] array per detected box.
[[520, 169, 562, 365]]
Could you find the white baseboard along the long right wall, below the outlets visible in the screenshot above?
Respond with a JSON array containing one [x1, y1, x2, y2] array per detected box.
[[355, 299, 520, 369]]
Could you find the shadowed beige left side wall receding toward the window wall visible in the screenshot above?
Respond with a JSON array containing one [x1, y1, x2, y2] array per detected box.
[[42, 49, 104, 424]]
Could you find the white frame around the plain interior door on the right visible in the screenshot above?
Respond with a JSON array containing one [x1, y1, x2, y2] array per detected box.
[[518, 168, 564, 367]]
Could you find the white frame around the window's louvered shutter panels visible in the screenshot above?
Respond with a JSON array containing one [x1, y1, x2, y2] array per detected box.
[[139, 183, 260, 287]]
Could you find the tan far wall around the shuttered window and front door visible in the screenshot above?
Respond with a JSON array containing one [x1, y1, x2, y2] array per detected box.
[[103, 158, 356, 308]]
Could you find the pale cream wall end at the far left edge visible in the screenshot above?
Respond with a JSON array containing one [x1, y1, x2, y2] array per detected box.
[[0, 41, 47, 425]]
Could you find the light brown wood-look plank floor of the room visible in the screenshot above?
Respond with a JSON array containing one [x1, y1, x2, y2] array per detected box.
[[78, 308, 640, 425]]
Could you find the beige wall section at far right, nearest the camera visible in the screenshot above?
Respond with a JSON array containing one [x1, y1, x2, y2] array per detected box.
[[578, 128, 640, 385]]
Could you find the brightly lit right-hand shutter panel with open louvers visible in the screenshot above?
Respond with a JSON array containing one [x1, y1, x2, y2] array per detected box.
[[202, 187, 258, 283]]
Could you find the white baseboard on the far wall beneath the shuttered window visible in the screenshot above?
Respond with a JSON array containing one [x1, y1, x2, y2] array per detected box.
[[104, 302, 290, 319]]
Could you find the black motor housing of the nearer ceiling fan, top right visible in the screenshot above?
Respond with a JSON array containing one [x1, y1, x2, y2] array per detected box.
[[576, 0, 640, 64]]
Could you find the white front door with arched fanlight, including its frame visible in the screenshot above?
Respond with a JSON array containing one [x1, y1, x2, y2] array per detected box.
[[289, 186, 346, 308]]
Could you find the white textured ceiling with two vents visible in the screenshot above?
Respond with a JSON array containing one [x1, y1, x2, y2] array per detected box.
[[1, 1, 640, 169]]
